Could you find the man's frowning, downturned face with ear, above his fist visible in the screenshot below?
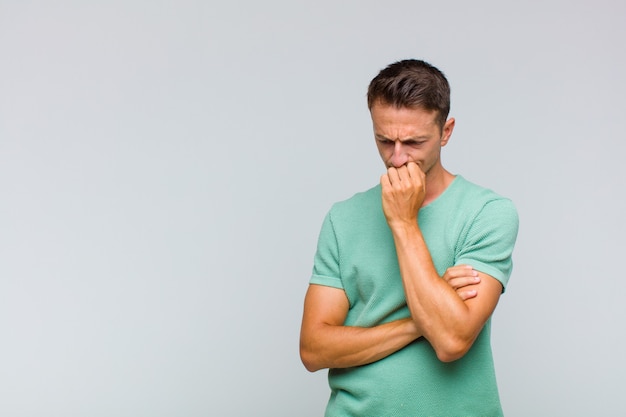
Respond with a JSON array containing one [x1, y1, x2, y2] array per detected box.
[[371, 103, 454, 175]]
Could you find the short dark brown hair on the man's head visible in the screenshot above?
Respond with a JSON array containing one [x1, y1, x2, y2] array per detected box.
[[367, 59, 450, 127]]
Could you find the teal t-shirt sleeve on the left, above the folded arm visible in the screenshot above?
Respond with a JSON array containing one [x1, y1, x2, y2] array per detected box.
[[309, 212, 343, 289]]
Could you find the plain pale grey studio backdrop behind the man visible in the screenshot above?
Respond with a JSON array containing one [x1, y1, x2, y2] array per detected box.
[[0, 0, 626, 417]]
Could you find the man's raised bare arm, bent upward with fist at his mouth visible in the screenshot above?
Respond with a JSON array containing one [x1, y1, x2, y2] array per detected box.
[[381, 163, 502, 362]]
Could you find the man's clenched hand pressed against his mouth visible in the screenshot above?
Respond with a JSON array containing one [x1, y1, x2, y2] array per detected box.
[[380, 162, 426, 226]]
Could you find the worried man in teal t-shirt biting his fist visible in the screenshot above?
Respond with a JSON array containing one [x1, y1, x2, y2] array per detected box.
[[300, 60, 518, 417]]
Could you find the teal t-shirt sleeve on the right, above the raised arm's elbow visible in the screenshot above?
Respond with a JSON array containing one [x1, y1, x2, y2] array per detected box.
[[456, 199, 519, 292]]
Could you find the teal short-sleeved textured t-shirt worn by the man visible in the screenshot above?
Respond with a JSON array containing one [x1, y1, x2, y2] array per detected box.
[[309, 176, 518, 417]]
